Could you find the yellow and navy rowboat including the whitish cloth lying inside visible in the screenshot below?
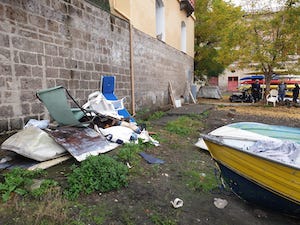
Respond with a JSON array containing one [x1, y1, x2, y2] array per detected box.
[[201, 129, 300, 216]]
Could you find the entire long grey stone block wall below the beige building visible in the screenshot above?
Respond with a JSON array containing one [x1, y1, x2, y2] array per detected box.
[[0, 0, 193, 133]]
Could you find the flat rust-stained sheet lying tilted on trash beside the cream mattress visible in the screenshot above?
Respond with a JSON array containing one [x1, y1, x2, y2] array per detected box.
[[47, 127, 118, 162]]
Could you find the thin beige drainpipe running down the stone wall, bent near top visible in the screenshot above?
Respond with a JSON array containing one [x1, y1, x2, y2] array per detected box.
[[113, 1, 135, 116]]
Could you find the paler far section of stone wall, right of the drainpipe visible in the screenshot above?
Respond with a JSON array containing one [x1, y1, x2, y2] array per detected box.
[[133, 30, 194, 110]]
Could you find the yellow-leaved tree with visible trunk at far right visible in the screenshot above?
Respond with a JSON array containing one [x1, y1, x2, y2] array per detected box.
[[237, 0, 300, 93]]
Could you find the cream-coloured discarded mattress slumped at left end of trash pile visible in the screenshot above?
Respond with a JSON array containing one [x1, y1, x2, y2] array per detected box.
[[1, 127, 66, 162]]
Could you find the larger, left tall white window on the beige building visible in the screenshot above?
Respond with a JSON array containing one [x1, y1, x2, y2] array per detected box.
[[155, 0, 165, 41]]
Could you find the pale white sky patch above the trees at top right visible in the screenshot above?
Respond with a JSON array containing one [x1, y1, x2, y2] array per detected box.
[[227, 0, 282, 11]]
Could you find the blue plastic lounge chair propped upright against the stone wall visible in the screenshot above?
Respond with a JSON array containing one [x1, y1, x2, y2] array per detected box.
[[100, 75, 136, 123]]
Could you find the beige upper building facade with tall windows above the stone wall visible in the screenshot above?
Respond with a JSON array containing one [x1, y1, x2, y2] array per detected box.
[[110, 0, 195, 57]]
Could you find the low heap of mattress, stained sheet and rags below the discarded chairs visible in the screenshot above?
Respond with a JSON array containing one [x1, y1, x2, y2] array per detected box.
[[0, 88, 159, 169]]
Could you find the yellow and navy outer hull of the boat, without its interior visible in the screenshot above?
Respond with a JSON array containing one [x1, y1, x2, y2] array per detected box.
[[203, 135, 300, 216]]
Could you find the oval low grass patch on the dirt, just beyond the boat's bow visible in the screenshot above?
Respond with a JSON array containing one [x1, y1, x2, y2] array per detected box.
[[166, 116, 202, 136]]
